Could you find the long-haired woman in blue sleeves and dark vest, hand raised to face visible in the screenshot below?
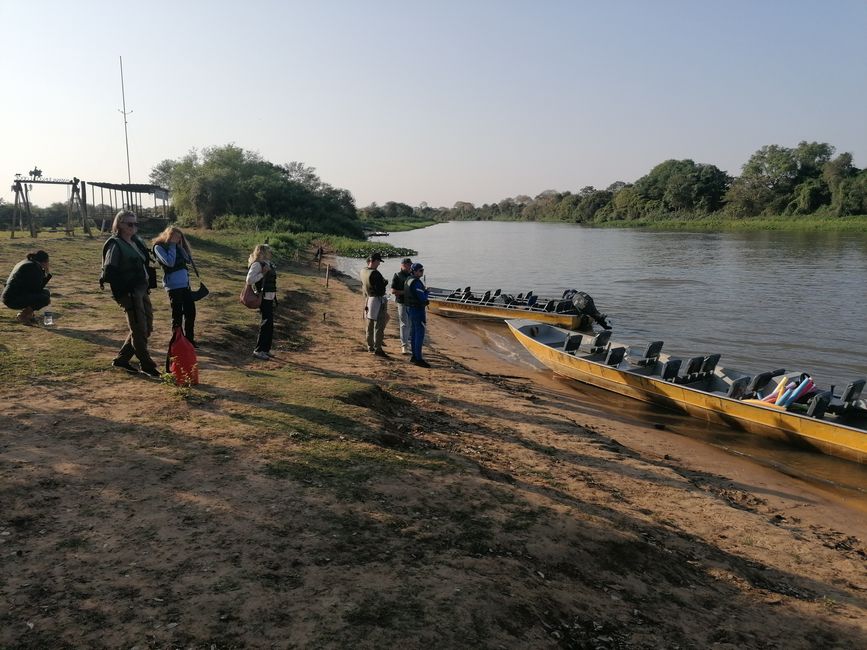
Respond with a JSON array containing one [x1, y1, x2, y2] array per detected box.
[[152, 226, 198, 347]]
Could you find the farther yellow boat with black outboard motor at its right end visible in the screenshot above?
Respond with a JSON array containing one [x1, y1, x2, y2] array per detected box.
[[428, 287, 608, 331]]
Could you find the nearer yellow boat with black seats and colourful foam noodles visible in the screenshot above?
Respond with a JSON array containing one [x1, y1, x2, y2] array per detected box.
[[506, 319, 867, 463]]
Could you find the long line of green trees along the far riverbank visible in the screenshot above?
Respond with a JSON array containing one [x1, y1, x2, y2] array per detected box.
[[382, 142, 867, 223]]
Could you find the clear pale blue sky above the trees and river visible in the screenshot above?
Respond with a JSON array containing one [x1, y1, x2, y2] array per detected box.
[[0, 0, 867, 207]]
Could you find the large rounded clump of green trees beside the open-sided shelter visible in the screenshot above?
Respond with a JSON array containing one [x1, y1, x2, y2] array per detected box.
[[150, 144, 363, 238]]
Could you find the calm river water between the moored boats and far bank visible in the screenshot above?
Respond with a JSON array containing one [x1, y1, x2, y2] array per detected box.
[[336, 221, 867, 494]]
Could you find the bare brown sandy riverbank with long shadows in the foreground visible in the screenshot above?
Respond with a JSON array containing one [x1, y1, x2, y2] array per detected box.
[[0, 251, 867, 648]]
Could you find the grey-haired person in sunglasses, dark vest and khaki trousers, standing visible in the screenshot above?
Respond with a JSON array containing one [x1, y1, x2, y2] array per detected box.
[[102, 210, 161, 378]]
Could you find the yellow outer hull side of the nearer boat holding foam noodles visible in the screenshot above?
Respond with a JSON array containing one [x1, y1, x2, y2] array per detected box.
[[507, 320, 867, 463]]
